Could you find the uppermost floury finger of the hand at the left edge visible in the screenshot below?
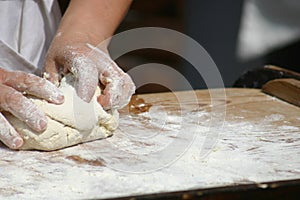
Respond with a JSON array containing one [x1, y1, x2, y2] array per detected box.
[[2, 72, 64, 104]]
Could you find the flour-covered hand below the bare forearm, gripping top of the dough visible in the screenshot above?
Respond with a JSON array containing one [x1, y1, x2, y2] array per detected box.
[[45, 33, 135, 110]]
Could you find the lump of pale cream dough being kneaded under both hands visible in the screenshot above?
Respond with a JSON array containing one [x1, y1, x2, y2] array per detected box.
[[6, 75, 119, 151]]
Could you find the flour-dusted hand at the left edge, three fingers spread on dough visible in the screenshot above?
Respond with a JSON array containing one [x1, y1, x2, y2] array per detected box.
[[0, 68, 64, 149]]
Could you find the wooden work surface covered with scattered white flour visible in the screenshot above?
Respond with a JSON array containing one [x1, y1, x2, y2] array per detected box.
[[0, 89, 300, 199]]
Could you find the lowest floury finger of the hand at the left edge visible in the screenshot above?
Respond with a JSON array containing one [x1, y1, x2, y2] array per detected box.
[[0, 113, 24, 149]]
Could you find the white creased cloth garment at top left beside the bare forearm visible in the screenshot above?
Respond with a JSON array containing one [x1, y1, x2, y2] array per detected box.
[[0, 0, 61, 75]]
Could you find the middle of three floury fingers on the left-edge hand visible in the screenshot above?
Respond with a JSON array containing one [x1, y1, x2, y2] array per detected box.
[[0, 85, 48, 132]]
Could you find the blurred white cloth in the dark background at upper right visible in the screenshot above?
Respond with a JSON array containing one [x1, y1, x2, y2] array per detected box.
[[237, 0, 300, 59]]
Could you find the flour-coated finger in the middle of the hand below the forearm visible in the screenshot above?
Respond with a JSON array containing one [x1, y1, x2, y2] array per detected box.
[[70, 56, 98, 102]]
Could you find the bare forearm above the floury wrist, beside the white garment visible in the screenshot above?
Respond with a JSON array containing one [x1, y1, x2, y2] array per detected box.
[[58, 0, 132, 46]]
